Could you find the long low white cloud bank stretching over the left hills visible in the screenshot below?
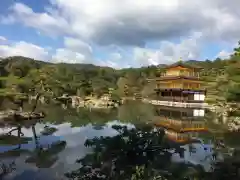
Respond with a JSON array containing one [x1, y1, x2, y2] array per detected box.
[[0, 36, 121, 68]]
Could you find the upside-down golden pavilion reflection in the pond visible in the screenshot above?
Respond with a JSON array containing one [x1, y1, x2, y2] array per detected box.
[[153, 106, 207, 142]]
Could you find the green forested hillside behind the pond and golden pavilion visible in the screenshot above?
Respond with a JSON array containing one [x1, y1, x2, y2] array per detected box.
[[0, 41, 240, 107]]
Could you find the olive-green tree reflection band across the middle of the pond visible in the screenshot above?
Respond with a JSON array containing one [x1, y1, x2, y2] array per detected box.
[[26, 101, 154, 127]]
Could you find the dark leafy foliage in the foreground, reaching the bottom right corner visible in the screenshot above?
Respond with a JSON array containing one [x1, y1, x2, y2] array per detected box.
[[65, 125, 240, 180]]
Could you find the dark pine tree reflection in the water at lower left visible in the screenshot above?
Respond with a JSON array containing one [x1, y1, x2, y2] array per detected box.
[[0, 121, 66, 179]]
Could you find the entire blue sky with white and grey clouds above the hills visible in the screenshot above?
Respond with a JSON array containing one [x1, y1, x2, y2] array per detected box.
[[0, 0, 240, 68]]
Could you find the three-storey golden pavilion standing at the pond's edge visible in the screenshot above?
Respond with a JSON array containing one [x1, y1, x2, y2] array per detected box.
[[150, 61, 206, 102]]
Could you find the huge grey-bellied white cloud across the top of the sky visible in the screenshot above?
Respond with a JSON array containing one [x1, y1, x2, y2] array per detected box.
[[2, 0, 240, 47]]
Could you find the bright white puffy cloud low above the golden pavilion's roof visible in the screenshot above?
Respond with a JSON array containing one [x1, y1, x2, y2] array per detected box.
[[133, 33, 202, 66]]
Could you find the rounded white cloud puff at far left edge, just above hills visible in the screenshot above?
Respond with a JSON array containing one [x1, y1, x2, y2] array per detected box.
[[0, 41, 49, 60]]
